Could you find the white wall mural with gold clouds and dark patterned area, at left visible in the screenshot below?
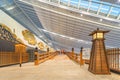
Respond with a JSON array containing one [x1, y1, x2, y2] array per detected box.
[[0, 10, 53, 51]]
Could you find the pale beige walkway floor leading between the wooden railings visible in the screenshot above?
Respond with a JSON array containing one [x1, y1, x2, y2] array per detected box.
[[0, 55, 120, 80]]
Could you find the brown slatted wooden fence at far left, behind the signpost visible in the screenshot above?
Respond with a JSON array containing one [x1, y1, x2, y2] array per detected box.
[[0, 52, 28, 66]]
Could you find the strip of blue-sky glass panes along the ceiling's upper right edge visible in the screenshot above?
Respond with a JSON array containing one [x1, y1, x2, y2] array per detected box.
[[51, 0, 120, 19]]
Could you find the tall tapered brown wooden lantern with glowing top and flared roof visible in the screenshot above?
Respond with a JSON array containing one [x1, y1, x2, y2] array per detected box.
[[88, 29, 110, 74]]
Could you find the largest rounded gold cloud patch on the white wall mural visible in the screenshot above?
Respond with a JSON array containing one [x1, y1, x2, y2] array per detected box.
[[22, 30, 37, 45]]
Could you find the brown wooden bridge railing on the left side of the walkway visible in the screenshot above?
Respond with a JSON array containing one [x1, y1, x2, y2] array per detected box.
[[34, 52, 58, 65]]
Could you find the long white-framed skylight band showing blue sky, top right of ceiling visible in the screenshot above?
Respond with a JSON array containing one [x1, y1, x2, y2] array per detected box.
[[45, 0, 120, 20]]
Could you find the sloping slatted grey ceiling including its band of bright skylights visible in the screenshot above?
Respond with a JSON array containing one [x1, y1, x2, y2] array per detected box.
[[1, 0, 120, 52]]
